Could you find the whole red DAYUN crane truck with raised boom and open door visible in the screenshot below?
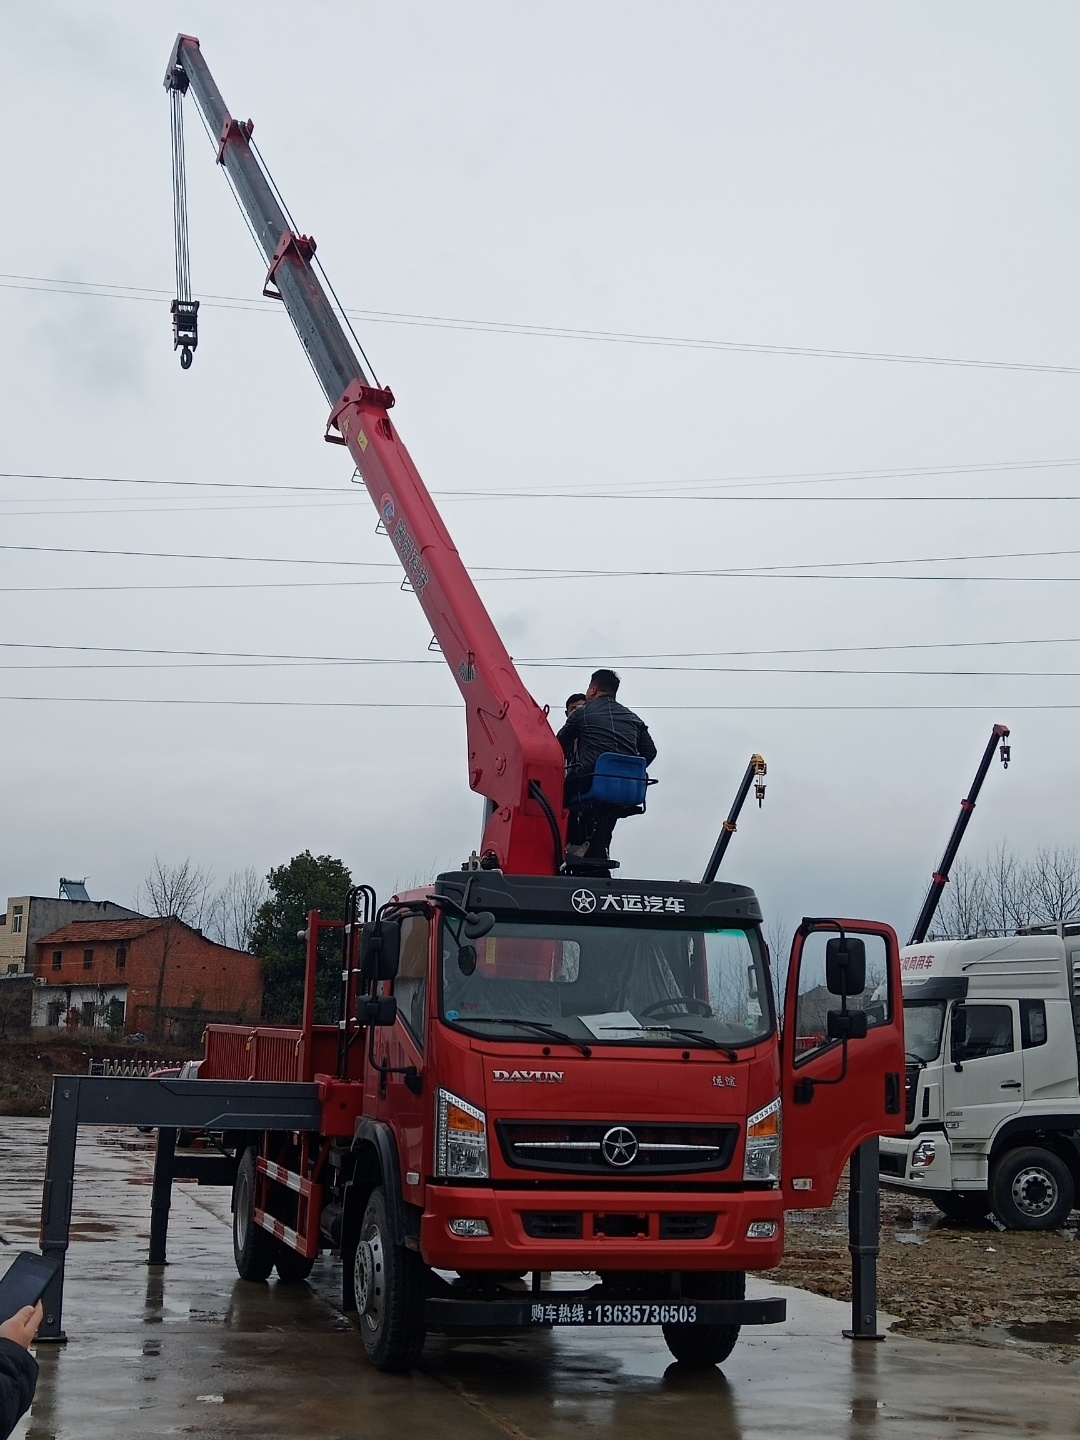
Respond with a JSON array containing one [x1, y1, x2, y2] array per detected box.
[[166, 35, 904, 1369]]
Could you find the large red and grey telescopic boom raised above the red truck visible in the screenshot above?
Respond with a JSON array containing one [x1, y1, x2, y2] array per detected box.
[[164, 35, 566, 876]]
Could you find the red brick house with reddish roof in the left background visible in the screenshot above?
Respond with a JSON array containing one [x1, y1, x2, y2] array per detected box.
[[33, 916, 262, 1044]]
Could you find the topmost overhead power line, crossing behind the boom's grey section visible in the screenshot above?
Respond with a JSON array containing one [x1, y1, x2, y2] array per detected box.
[[0, 274, 1080, 374]]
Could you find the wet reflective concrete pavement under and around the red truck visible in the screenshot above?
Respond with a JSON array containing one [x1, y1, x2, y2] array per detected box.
[[0, 1117, 1080, 1440]]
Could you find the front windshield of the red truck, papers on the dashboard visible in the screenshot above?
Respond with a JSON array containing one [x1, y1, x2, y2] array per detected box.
[[441, 919, 772, 1048]]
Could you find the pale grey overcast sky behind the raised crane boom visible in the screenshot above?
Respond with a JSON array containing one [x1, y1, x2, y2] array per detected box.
[[0, 0, 1080, 930]]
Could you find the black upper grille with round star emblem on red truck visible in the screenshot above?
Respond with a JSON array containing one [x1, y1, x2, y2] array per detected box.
[[495, 1120, 739, 1179]]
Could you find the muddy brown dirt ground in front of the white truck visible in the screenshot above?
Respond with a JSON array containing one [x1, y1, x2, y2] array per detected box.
[[770, 1191, 1080, 1362]]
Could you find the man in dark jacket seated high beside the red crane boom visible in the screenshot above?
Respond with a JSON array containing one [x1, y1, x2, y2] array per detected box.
[[559, 670, 657, 860]]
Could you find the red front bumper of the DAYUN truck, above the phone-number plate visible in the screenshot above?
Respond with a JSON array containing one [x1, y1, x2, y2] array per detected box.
[[420, 1185, 783, 1272]]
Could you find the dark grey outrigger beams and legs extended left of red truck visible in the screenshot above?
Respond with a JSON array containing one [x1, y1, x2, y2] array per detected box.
[[37, 1076, 323, 1341]]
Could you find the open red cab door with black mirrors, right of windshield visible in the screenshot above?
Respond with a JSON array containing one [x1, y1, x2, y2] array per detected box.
[[780, 919, 904, 1210]]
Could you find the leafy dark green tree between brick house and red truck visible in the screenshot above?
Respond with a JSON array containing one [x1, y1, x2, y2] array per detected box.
[[251, 850, 353, 1025]]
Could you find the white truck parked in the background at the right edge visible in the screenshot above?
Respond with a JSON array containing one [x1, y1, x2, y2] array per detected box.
[[880, 923, 1080, 1230]]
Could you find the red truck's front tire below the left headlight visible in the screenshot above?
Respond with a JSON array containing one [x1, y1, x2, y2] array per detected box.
[[353, 1185, 428, 1371]]
